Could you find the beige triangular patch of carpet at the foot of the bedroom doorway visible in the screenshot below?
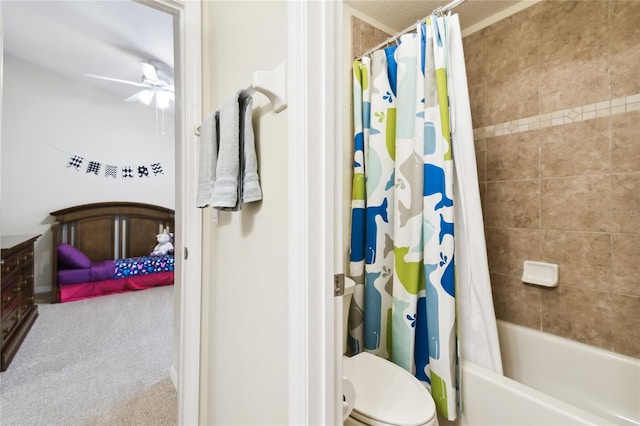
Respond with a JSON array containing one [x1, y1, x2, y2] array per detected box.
[[87, 377, 178, 426]]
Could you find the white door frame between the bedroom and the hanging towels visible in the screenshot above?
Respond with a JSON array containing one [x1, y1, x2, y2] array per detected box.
[[143, 0, 202, 425]]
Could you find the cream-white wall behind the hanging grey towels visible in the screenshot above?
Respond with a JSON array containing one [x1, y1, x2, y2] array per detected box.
[[200, 1, 288, 425]]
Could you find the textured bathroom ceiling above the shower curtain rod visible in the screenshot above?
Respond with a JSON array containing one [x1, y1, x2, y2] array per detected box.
[[344, 0, 536, 32]]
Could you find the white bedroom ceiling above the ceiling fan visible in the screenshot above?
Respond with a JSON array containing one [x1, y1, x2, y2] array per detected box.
[[2, 0, 173, 103]]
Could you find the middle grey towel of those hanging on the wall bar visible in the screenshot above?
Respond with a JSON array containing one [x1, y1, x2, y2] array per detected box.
[[211, 90, 242, 209]]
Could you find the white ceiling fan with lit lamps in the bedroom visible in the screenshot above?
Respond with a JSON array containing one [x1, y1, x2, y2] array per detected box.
[[85, 60, 175, 109]]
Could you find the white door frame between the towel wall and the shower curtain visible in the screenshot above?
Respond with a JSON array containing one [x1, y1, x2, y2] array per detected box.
[[287, 0, 343, 425]]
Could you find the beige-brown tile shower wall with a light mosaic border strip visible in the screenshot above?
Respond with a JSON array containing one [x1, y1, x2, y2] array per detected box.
[[352, 1, 640, 358]]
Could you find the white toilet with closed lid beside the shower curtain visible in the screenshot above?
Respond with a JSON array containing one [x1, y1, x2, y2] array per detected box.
[[342, 277, 438, 426]]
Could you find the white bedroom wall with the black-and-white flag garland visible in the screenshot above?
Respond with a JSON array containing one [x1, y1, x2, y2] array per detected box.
[[0, 55, 175, 292]]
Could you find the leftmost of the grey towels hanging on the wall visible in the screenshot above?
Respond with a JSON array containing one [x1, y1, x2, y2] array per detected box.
[[196, 111, 219, 207]]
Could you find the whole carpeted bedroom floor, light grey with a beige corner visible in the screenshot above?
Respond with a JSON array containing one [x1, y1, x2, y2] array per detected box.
[[0, 286, 177, 426]]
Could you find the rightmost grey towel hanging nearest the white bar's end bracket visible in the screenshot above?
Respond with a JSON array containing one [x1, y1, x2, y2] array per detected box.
[[240, 91, 262, 203]]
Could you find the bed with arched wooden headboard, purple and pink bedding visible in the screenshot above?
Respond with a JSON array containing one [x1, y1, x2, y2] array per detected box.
[[50, 201, 175, 302]]
